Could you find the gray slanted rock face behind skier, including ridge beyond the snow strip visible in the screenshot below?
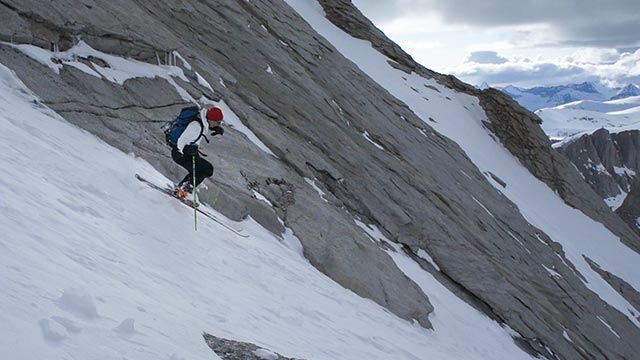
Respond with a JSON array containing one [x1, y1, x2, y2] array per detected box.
[[0, 0, 640, 359]]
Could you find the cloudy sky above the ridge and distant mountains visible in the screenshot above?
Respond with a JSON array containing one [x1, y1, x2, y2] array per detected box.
[[352, 0, 640, 87]]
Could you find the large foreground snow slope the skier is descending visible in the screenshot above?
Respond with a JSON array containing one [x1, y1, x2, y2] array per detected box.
[[0, 59, 531, 360]]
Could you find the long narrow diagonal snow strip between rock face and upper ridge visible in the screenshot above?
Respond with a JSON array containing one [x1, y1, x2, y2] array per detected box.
[[287, 0, 640, 327]]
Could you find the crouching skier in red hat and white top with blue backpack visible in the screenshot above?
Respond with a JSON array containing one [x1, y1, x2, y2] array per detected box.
[[163, 106, 224, 198]]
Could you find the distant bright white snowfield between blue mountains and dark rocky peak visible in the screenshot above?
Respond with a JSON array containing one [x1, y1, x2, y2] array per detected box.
[[536, 96, 640, 141]]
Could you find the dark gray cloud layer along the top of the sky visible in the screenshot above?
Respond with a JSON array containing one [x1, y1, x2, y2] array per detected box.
[[353, 0, 640, 48]]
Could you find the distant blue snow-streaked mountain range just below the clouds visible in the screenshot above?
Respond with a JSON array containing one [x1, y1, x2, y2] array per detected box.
[[496, 82, 640, 111]]
